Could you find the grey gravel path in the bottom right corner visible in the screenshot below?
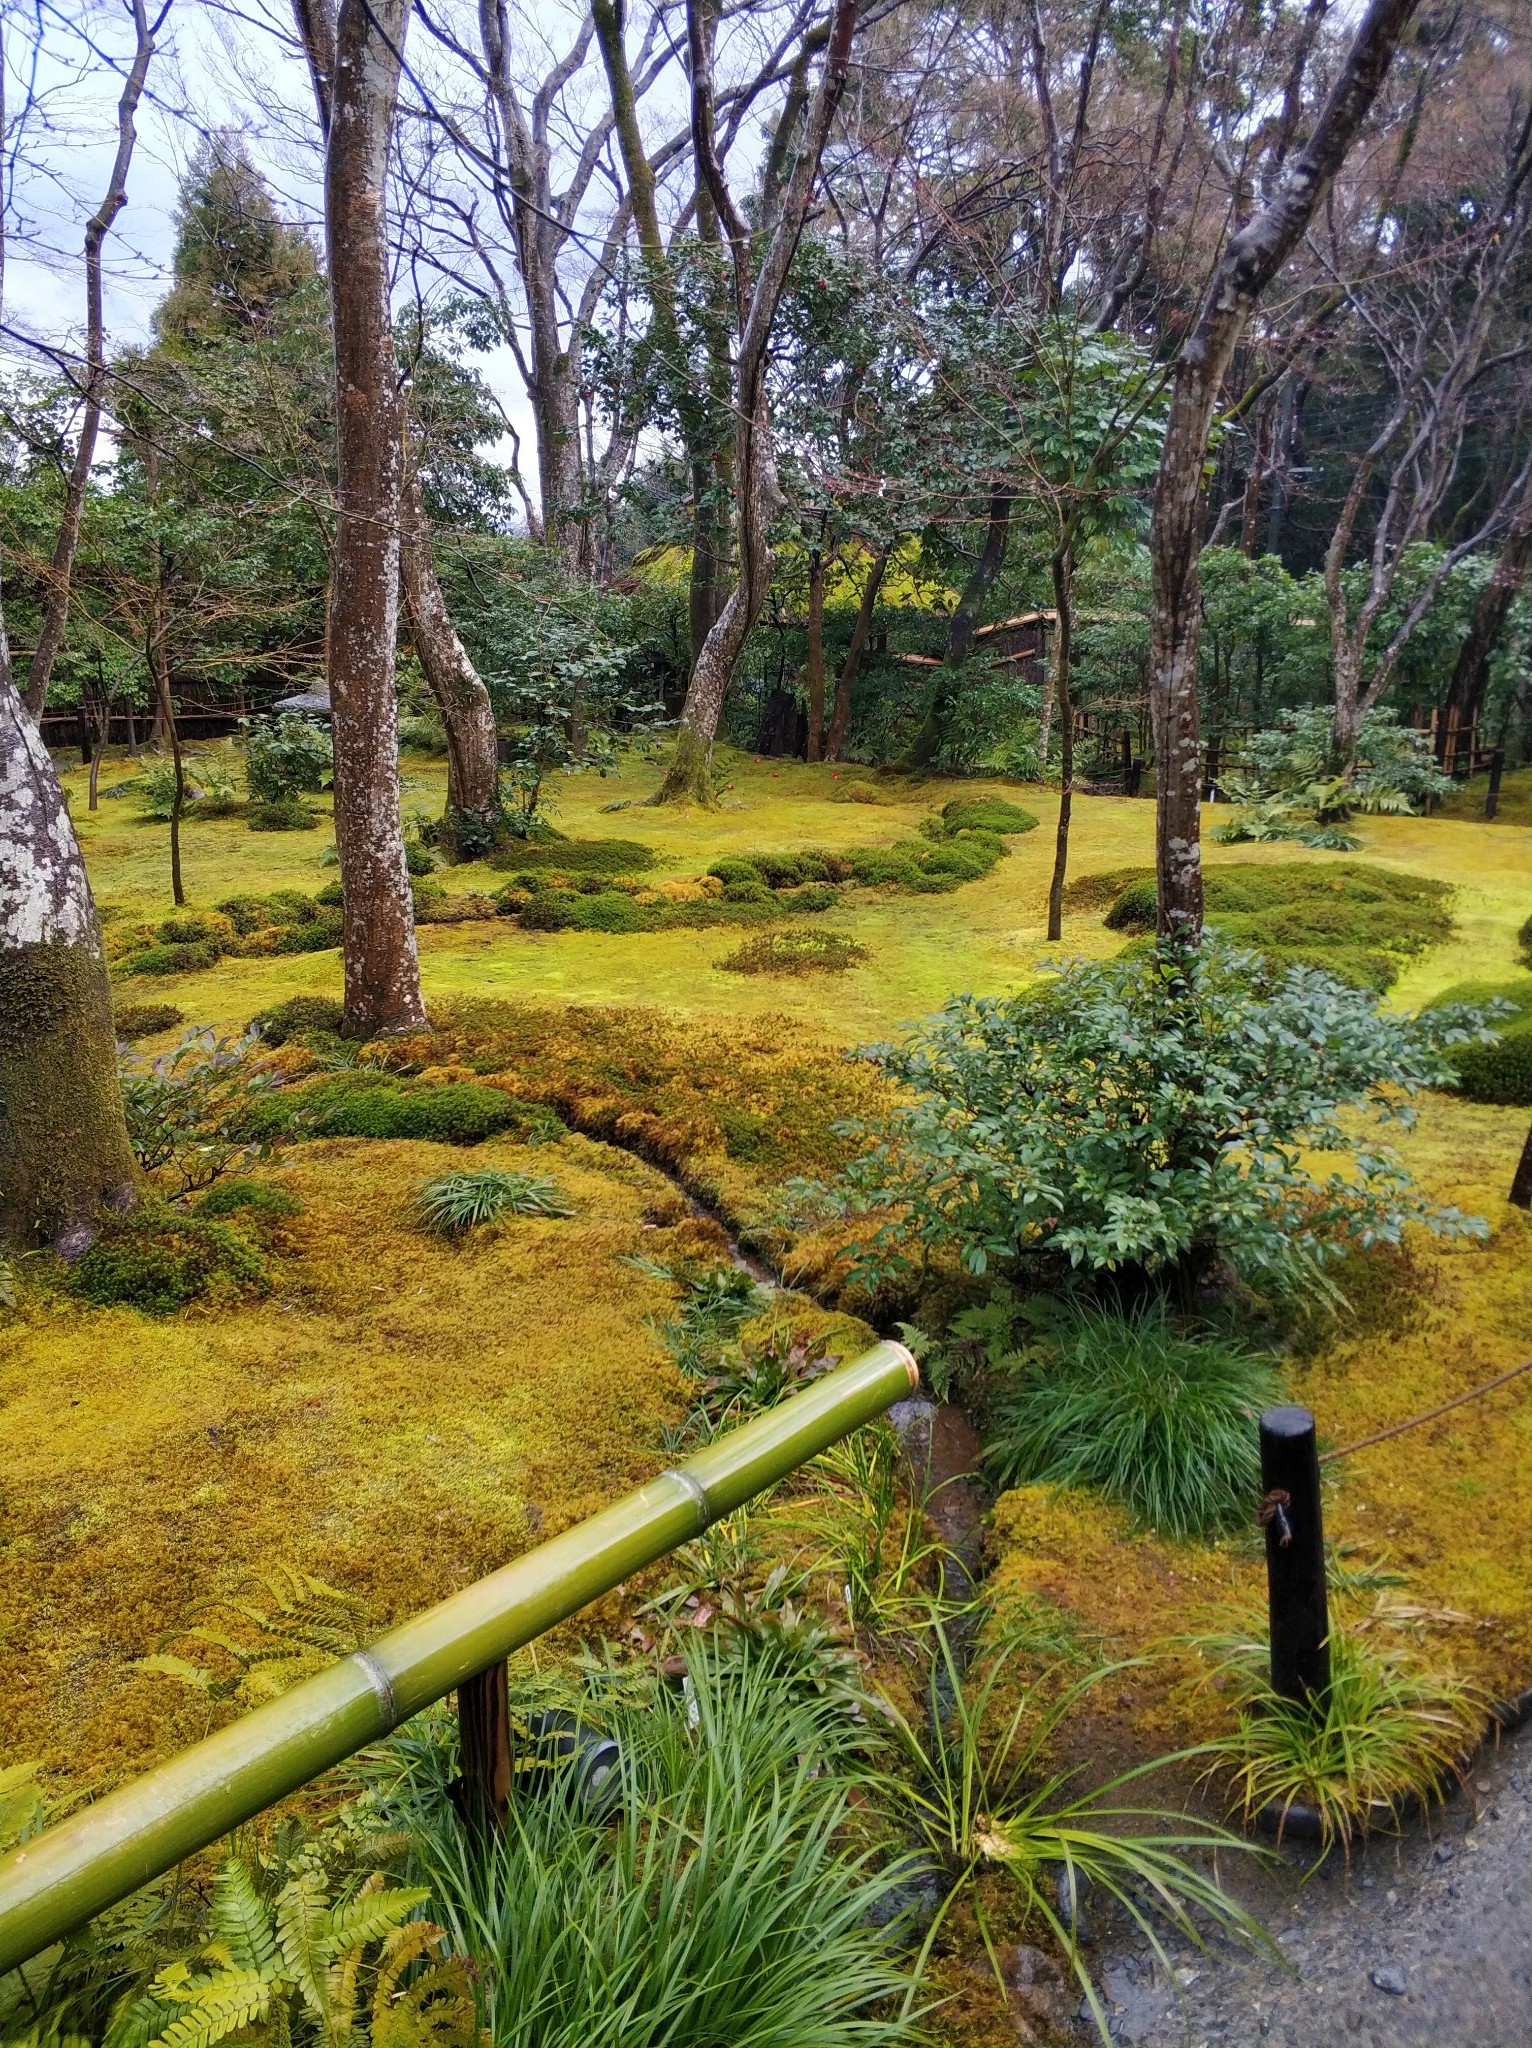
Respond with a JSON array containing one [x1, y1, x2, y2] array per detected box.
[[1079, 1729, 1532, 2048]]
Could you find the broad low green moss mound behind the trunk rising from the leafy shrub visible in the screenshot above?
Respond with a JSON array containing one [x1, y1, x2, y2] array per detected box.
[[1104, 860, 1452, 991]]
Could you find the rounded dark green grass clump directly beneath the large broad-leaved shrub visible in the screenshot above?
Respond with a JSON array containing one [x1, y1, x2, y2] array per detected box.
[[987, 1303, 1282, 1536]]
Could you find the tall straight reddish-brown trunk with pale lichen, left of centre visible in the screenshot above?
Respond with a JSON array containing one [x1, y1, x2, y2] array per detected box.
[[299, 0, 426, 1036]]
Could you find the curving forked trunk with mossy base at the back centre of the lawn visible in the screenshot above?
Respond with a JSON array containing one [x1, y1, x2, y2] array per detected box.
[[653, 0, 856, 805]]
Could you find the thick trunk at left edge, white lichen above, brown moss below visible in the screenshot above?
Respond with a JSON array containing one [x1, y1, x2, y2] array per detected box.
[[0, 647, 137, 1255]]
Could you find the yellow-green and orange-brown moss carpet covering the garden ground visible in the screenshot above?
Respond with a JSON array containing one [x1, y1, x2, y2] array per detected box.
[[0, 756, 1532, 1982]]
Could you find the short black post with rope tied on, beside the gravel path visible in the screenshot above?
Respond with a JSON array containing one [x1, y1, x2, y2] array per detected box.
[[1262, 1407, 1329, 1704]]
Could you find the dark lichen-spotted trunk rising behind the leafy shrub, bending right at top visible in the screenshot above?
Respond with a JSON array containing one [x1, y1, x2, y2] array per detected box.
[[1149, 0, 1417, 944]]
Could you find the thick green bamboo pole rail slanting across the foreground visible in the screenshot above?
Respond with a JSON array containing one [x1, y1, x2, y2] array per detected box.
[[0, 1343, 920, 1974]]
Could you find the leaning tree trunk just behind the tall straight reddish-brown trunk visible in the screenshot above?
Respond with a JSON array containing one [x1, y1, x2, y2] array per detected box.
[[399, 453, 500, 860]]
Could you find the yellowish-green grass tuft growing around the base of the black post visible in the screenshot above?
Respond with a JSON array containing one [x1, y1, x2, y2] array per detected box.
[[1198, 1610, 1489, 1849]]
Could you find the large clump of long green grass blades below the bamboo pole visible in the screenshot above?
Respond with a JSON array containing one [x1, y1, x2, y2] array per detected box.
[[367, 1640, 913, 2048]]
